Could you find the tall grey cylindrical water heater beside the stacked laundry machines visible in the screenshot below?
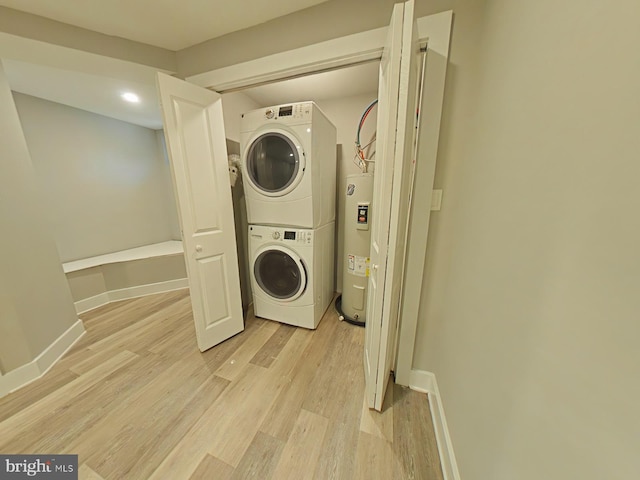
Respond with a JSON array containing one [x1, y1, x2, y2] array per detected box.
[[342, 173, 373, 322]]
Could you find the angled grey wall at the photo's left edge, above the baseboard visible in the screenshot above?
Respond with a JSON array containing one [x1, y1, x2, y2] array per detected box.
[[0, 63, 77, 373]]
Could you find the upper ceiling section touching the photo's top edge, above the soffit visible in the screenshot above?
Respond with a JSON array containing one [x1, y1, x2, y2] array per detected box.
[[0, 0, 327, 50]]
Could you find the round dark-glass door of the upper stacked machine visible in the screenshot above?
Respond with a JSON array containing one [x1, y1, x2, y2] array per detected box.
[[243, 129, 305, 197]]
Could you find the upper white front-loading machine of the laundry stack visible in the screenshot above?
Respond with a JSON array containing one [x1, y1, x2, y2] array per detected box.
[[240, 102, 336, 228]]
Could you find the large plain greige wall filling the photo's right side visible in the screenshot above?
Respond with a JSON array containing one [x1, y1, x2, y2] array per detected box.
[[414, 0, 640, 480]]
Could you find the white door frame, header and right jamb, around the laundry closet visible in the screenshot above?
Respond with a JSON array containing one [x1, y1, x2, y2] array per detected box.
[[186, 10, 453, 386]]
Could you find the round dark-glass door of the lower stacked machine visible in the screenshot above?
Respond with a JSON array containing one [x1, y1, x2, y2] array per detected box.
[[253, 245, 307, 301]]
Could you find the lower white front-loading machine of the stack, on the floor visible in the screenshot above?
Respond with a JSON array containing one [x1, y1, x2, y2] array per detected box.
[[249, 222, 334, 329]]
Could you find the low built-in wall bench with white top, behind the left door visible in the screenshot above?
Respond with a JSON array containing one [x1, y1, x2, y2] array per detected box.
[[62, 240, 188, 313]]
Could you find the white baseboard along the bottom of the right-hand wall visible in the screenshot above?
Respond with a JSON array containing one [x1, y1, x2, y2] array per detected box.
[[409, 370, 460, 480]]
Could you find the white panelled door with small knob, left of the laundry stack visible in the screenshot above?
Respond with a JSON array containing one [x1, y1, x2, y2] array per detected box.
[[157, 73, 244, 351]]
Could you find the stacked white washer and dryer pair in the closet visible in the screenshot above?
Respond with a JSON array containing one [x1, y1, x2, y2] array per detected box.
[[240, 102, 336, 329]]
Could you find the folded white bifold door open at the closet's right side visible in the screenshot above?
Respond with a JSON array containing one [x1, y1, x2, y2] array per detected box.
[[364, 0, 420, 410]]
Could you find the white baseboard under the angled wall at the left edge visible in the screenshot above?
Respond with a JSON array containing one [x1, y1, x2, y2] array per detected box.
[[0, 319, 84, 397]]
